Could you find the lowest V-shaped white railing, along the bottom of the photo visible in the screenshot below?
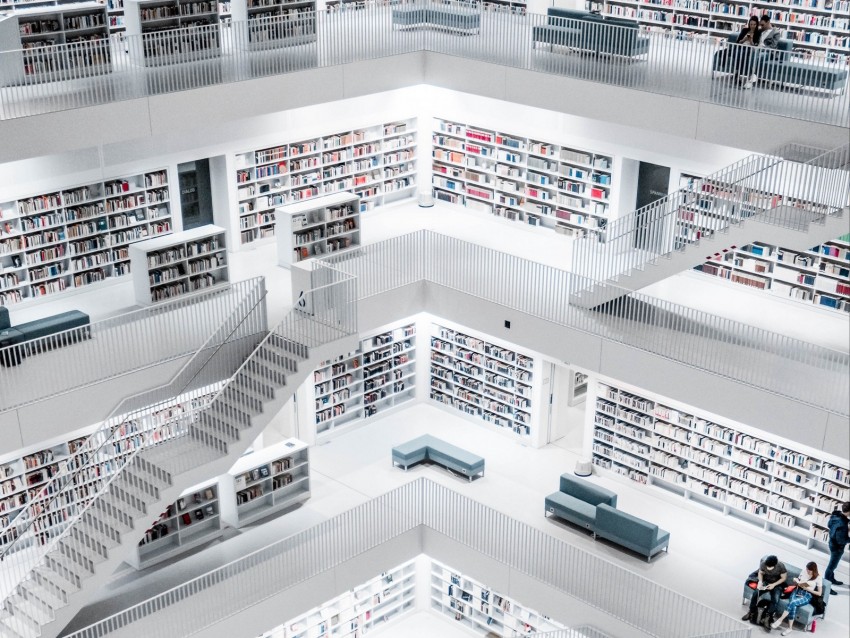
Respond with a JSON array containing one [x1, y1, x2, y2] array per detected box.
[[61, 478, 750, 638]]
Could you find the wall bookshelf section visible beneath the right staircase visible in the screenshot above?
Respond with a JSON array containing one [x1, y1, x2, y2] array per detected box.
[[696, 235, 850, 312]]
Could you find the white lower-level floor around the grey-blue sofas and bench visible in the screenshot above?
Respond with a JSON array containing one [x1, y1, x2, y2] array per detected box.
[[68, 403, 850, 638]]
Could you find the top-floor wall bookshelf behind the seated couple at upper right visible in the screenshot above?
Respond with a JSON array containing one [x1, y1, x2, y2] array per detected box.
[[588, 0, 850, 65]]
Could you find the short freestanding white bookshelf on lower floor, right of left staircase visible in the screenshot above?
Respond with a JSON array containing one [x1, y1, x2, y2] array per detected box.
[[221, 439, 310, 528]]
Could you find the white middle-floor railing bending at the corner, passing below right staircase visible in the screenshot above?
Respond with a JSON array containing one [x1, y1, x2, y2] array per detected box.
[[325, 230, 850, 415]]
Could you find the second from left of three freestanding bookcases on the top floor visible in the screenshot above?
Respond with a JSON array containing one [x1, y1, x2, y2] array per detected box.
[[124, 0, 221, 66]]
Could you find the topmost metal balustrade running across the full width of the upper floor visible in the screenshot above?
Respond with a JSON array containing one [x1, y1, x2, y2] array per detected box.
[[0, 0, 850, 126]]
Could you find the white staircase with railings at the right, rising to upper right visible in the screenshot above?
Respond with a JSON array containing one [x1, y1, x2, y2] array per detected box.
[[570, 146, 850, 308]]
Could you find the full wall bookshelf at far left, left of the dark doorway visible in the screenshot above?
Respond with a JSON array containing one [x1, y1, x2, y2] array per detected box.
[[0, 169, 171, 305]]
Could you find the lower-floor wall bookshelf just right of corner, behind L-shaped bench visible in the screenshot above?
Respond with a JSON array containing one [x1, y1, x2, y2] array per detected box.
[[430, 324, 534, 439]]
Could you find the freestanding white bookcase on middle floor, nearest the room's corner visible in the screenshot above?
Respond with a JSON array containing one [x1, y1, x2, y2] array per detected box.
[[274, 193, 360, 268]]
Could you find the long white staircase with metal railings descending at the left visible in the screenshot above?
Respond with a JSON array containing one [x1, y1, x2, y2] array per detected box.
[[0, 266, 357, 635]]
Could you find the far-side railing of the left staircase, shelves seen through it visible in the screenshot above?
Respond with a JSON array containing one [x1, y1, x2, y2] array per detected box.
[[0, 278, 267, 598]]
